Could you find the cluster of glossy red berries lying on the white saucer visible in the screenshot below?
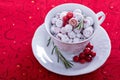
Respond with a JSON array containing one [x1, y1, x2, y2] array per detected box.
[[73, 43, 96, 64]]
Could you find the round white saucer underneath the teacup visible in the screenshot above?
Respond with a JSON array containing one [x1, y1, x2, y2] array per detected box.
[[32, 24, 111, 76]]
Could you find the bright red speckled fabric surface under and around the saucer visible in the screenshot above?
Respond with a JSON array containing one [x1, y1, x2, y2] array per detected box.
[[0, 0, 120, 80]]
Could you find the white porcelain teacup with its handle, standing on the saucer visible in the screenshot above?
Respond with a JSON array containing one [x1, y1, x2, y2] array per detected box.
[[45, 3, 105, 53]]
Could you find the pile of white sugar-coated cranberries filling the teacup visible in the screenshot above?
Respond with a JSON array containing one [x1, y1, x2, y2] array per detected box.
[[50, 9, 94, 43]]
